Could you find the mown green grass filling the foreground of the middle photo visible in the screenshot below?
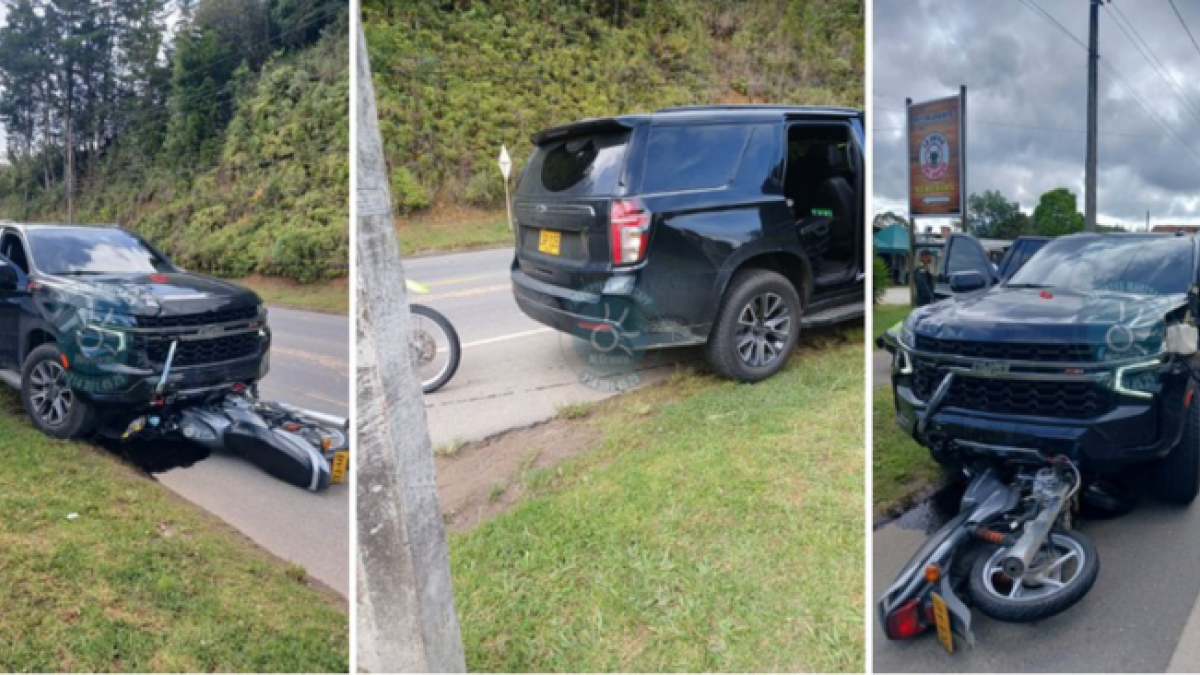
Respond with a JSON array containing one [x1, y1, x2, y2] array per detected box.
[[451, 330, 865, 671]]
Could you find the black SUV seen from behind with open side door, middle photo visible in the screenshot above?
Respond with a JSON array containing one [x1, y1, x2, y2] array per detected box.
[[511, 106, 865, 382]]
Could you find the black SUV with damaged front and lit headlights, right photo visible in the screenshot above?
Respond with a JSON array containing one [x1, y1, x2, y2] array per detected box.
[[882, 234, 1200, 503]]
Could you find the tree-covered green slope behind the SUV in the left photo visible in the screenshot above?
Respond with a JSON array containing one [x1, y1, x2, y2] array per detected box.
[[0, 0, 349, 282]]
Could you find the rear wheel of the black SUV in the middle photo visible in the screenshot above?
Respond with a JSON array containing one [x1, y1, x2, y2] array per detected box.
[[707, 269, 803, 382]]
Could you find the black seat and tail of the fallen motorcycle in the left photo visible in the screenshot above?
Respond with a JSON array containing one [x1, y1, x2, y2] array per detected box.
[[226, 420, 330, 492]]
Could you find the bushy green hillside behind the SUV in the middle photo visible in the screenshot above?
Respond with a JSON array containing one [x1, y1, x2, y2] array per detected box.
[[364, 0, 864, 214]]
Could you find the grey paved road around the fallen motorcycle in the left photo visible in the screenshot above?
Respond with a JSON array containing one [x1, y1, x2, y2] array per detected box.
[[150, 307, 353, 598]]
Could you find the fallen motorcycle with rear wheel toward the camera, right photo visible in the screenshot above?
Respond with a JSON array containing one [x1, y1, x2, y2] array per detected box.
[[877, 446, 1100, 653]]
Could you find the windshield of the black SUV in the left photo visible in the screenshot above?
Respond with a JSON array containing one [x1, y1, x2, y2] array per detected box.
[[28, 227, 175, 274]]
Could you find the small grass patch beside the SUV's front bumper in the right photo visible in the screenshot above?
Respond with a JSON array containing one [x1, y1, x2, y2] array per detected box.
[[871, 387, 942, 513]]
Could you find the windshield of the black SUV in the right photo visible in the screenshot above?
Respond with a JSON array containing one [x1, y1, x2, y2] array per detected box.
[[1007, 237, 1195, 295]]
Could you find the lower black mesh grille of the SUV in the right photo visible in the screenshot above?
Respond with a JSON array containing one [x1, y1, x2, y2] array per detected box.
[[912, 360, 1116, 419]]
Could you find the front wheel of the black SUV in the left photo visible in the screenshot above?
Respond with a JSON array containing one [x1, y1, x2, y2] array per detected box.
[[20, 345, 96, 440]]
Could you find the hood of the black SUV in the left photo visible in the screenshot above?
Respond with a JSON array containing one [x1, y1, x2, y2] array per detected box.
[[43, 271, 262, 317]]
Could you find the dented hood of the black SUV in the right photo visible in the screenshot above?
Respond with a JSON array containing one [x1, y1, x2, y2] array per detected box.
[[908, 286, 1187, 345]]
